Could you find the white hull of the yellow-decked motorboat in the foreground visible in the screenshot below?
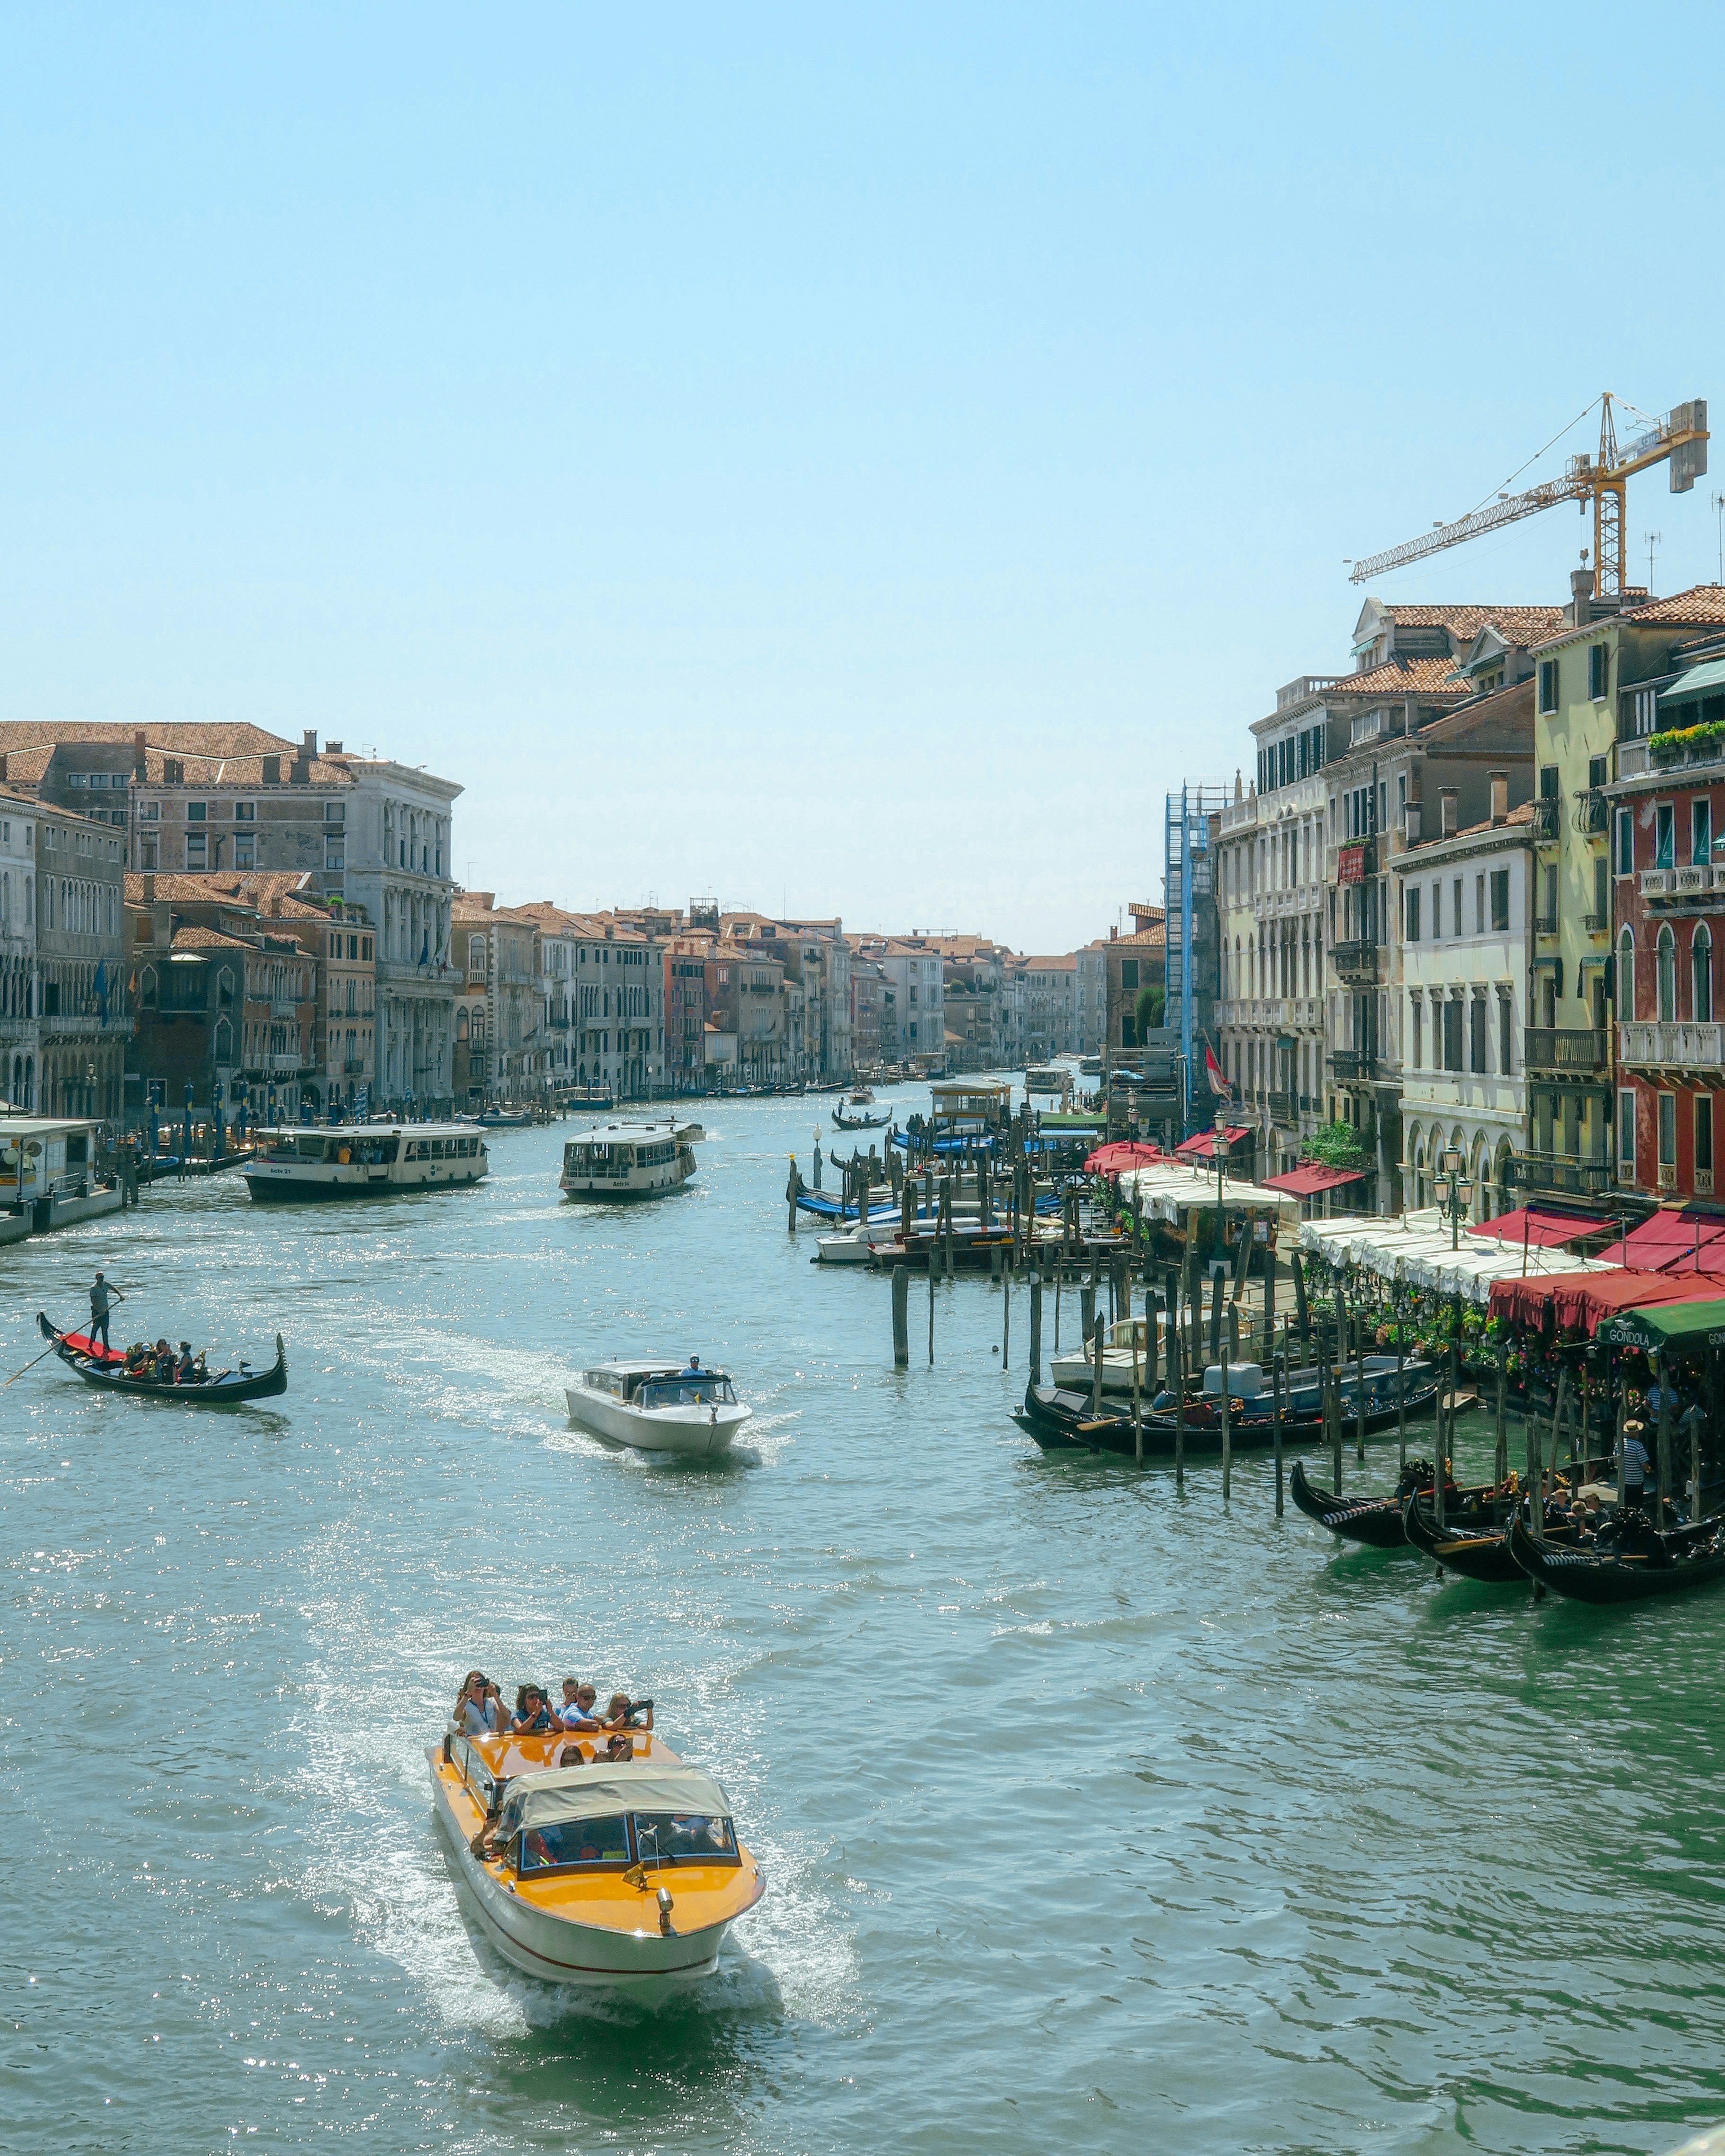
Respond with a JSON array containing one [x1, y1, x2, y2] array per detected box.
[[425, 1746, 735, 2003]]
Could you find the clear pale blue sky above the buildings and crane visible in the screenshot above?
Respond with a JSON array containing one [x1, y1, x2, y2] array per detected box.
[[0, 0, 1725, 951]]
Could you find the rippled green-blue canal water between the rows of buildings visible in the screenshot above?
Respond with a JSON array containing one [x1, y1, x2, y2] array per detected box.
[[0, 1095, 1725, 2156]]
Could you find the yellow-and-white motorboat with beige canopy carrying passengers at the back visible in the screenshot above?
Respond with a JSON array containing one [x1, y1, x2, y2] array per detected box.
[[425, 1729, 765, 2003]]
